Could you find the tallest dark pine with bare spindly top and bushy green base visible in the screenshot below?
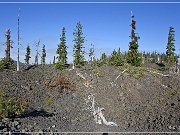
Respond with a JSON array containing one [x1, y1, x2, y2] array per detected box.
[[127, 12, 142, 66]]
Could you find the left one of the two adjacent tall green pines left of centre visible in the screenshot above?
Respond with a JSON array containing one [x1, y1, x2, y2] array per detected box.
[[56, 27, 67, 70]]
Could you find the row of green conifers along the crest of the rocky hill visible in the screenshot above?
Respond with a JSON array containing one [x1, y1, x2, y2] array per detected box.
[[0, 15, 176, 70]]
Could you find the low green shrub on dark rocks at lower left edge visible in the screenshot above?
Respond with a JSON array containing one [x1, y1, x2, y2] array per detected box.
[[0, 90, 27, 119]]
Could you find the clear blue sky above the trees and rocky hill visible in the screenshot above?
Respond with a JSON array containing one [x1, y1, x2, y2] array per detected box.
[[0, 0, 180, 63]]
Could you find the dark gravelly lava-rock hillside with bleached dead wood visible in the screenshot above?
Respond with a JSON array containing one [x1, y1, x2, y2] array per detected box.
[[0, 65, 180, 134]]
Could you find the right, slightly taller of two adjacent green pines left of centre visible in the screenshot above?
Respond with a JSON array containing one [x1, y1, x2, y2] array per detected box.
[[73, 22, 85, 67]]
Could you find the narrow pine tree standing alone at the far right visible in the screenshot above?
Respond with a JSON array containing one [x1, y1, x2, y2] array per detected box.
[[166, 27, 175, 65]]
